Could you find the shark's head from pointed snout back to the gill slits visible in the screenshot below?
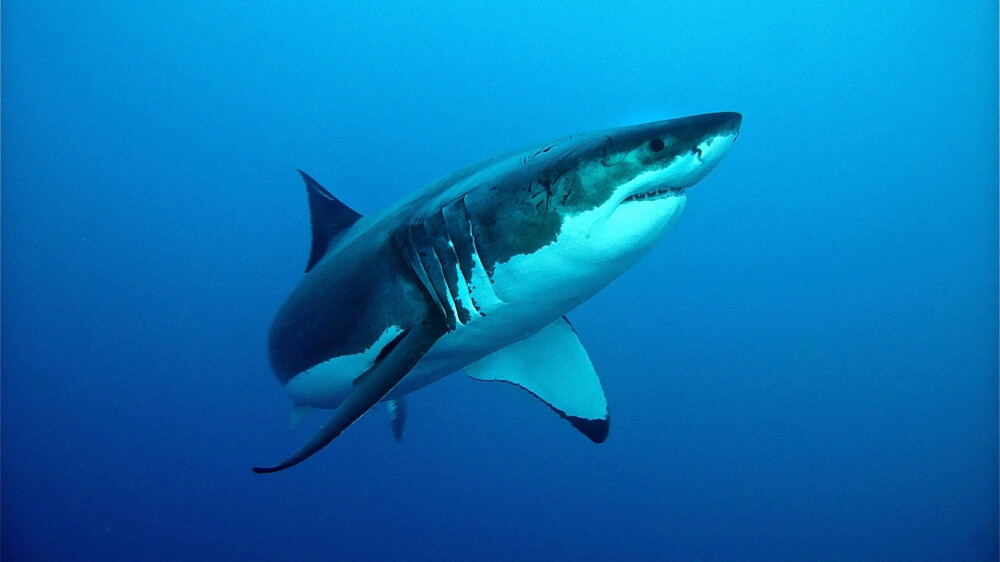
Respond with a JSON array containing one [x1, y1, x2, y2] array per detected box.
[[470, 113, 742, 301]]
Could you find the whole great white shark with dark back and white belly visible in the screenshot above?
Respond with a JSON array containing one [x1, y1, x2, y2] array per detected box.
[[253, 112, 742, 473]]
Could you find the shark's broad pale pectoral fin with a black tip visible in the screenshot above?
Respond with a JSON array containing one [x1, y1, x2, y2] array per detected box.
[[465, 317, 608, 443]]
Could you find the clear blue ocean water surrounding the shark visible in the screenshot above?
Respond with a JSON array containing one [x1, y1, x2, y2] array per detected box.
[[0, 0, 998, 561]]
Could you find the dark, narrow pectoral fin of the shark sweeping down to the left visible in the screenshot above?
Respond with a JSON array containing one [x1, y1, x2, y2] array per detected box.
[[253, 318, 446, 474]]
